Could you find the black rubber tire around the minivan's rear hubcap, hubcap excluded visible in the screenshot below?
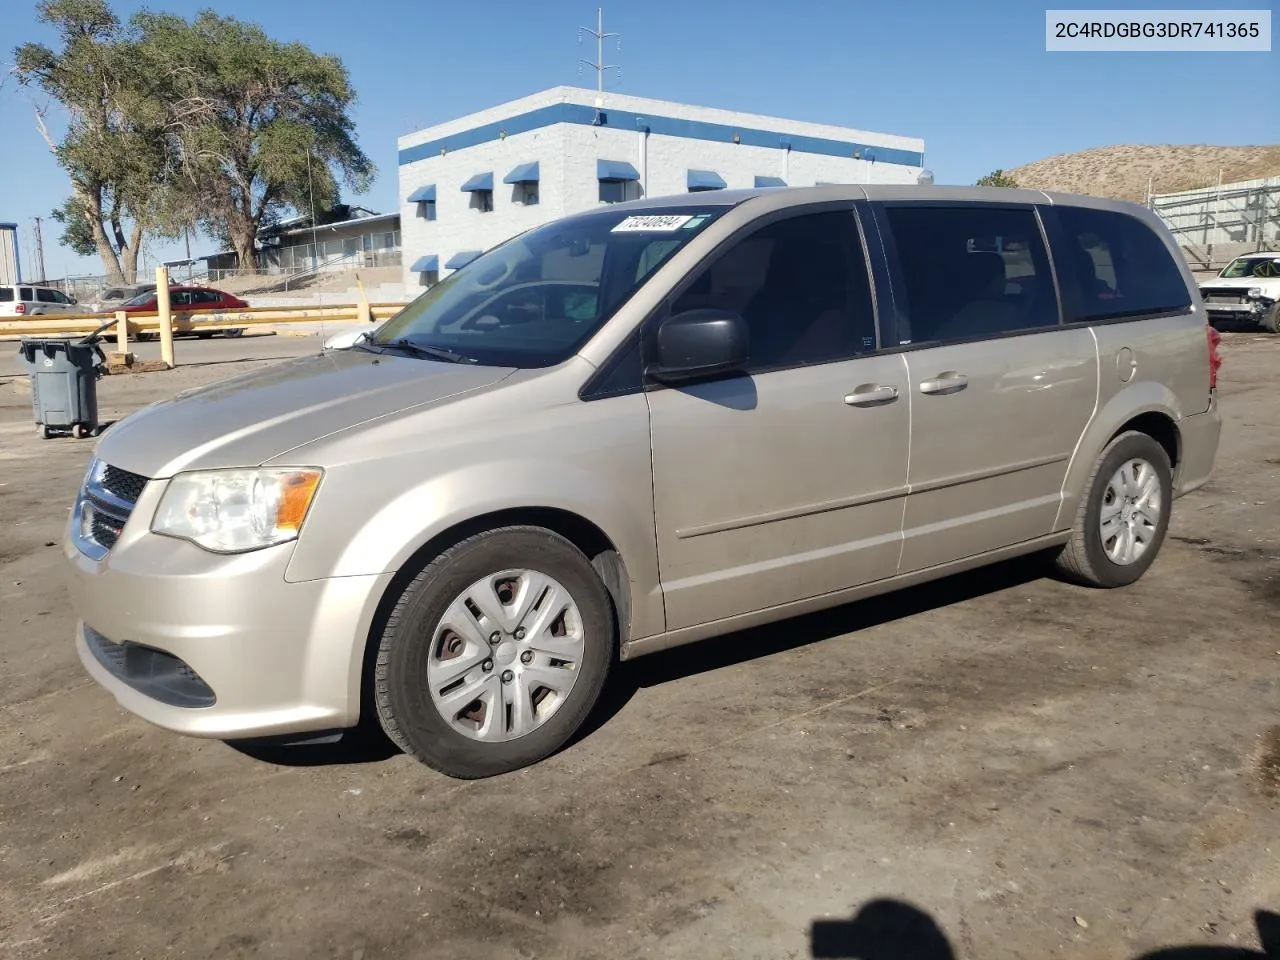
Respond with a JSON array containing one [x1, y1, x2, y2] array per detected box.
[[1055, 430, 1174, 589]]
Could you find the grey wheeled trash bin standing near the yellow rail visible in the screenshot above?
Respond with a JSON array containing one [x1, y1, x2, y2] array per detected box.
[[18, 335, 106, 440]]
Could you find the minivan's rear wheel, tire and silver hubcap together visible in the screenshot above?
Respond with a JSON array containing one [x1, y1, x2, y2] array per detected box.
[[1057, 430, 1174, 588]]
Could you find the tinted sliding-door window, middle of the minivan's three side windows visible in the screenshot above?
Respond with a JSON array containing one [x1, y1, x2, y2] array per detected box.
[[884, 204, 1059, 344]]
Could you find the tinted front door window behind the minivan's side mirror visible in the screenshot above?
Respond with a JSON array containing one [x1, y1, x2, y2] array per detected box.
[[672, 210, 876, 371]]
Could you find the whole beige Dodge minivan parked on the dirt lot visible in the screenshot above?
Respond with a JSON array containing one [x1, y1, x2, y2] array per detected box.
[[65, 187, 1220, 777]]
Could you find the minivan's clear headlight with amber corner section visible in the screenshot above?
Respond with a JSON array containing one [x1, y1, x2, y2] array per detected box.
[[151, 470, 323, 553]]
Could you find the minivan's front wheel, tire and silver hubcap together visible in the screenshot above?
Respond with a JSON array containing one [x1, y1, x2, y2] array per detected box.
[[374, 526, 617, 780]]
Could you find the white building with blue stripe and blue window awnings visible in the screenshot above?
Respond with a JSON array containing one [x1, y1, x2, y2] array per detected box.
[[399, 87, 924, 289]]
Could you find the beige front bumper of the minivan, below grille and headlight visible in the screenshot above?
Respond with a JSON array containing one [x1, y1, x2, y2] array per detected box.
[[63, 512, 392, 740]]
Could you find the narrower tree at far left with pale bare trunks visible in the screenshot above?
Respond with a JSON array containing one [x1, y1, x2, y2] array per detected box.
[[14, 0, 163, 283]]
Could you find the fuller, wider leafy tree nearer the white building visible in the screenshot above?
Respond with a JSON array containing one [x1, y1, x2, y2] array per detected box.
[[133, 10, 375, 270]]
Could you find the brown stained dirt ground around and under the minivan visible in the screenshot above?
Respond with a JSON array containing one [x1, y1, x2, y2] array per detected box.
[[0, 334, 1280, 960]]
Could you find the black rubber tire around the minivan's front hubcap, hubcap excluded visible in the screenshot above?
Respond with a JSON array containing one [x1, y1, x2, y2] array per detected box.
[[374, 526, 617, 780]]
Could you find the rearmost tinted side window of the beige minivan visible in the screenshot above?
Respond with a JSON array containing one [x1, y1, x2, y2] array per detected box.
[[1055, 207, 1190, 320]]
